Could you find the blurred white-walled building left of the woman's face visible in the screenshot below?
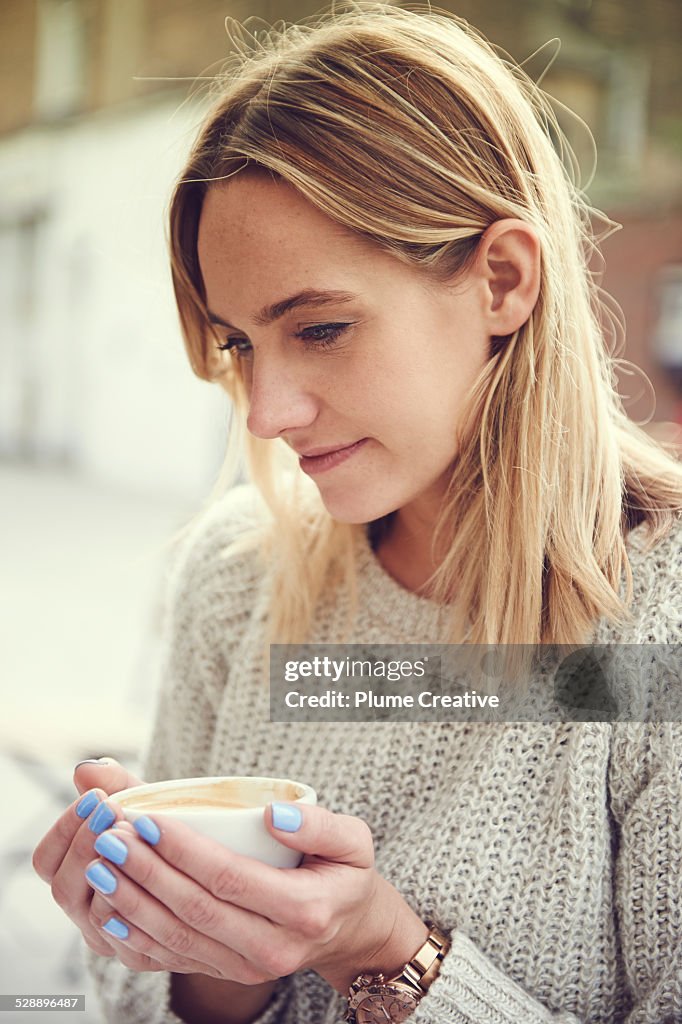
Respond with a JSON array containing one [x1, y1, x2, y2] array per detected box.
[[0, 0, 248, 496]]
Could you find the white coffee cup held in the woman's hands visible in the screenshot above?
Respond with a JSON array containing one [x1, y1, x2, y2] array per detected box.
[[111, 776, 317, 867]]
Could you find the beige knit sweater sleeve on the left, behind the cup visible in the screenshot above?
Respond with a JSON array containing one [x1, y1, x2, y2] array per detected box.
[[85, 488, 290, 1024]]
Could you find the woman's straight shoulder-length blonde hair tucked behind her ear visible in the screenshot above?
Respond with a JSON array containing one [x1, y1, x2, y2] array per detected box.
[[170, 2, 682, 644]]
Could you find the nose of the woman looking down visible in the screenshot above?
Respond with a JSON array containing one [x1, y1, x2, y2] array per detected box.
[[247, 353, 318, 437]]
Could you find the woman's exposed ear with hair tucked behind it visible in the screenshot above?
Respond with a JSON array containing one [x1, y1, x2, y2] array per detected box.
[[476, 218, 541, 337]]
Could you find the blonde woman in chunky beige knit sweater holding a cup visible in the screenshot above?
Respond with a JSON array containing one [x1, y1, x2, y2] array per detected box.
[[34, 5, 682, 1024]]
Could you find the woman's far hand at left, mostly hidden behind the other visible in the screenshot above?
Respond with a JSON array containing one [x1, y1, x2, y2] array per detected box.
[[33, 758, 145, 956]]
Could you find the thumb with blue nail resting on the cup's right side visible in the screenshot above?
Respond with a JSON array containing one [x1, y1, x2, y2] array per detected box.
[[265, 802, 374, 867]]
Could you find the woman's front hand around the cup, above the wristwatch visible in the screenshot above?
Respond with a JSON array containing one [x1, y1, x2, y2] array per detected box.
[[84, 804, 427, 992]]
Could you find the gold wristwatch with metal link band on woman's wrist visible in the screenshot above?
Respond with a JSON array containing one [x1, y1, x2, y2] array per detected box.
[[346, 928, 447, 1024]]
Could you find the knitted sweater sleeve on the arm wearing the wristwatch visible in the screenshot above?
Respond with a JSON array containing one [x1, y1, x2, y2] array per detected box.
[[401, 722, 682, 1024]]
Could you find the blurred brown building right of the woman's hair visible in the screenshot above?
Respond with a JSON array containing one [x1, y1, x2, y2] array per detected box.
[[462, 0, 682, 423]]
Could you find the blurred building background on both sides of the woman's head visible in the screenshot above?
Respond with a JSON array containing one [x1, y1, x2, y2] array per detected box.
[[0, 0, 682, 489]]
